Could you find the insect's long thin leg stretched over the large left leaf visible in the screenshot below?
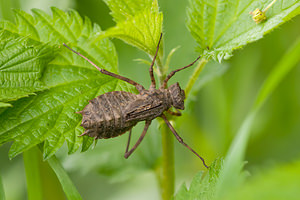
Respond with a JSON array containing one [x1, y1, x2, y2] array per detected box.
[[63, 43, 145, 92]]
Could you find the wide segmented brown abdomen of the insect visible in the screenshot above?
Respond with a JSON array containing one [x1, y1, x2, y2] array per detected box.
[[79, 91, 137, 139]]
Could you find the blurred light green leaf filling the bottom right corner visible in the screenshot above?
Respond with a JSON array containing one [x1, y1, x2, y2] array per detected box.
[[226, 161, 300, 200]]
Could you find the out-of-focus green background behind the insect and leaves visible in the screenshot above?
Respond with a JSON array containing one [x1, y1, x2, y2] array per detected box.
[[0, 0, 300, 200]]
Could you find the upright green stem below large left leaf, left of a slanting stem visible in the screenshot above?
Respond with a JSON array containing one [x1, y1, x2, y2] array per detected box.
[[23, 147, 43, 200]]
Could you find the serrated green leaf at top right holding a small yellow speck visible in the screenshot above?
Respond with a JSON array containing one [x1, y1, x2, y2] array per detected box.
[[187, 0, 300, 62]]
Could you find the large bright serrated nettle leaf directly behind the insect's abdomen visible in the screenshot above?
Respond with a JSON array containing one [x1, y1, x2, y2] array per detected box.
[[0, 8, 132, 159]]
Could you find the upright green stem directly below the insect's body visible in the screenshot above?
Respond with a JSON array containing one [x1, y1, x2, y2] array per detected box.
[[161, 124, 175, 200]]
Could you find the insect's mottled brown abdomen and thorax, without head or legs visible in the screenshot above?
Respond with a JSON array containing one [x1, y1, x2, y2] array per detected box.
[[79, 89, 176, 139]]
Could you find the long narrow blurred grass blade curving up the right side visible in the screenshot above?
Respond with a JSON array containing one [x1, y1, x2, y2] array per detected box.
[[217, 35, 300, 198]]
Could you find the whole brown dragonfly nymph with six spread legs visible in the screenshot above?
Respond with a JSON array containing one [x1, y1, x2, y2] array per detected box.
[[64, 34, 208, 168]]
